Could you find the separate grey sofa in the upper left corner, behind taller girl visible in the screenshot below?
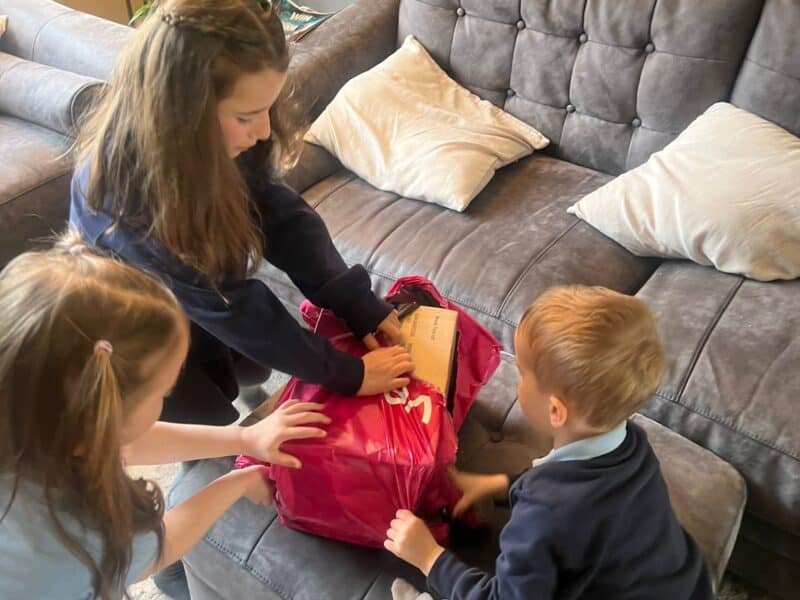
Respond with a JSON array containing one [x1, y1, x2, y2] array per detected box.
[[0, 0, 130, 266]]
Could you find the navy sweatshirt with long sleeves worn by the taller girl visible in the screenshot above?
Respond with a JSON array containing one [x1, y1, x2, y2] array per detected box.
[[70, 167, 391, 395]]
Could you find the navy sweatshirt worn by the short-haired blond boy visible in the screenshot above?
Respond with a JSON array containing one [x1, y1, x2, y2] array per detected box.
[[428, 422, 713, 600]]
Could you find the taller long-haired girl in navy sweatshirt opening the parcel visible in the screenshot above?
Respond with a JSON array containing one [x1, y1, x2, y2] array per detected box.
[[70, 0, 413, 424]]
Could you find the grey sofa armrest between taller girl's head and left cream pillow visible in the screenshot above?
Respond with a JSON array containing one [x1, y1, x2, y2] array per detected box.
[[289, 0, 400, 124]]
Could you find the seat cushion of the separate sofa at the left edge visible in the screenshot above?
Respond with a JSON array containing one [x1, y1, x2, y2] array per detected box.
[[0, 115, 72, 265]]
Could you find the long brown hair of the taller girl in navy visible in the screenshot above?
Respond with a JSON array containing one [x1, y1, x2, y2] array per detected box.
[[77, 0, 302, 281]]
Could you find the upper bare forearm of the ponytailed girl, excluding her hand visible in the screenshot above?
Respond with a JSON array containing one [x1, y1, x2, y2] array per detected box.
[[122, 421, 244, 465]]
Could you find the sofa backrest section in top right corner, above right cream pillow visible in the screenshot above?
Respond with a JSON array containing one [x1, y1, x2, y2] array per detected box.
[[732, 0, 800, 135]]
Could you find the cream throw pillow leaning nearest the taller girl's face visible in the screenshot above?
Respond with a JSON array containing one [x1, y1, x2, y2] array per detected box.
[[306, 36, 549, 211]]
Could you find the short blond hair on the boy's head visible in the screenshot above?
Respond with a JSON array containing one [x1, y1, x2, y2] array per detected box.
[[517, 285, 666, 428]]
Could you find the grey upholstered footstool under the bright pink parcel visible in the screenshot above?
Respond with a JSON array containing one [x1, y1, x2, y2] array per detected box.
[[178, 354, 745, 600]]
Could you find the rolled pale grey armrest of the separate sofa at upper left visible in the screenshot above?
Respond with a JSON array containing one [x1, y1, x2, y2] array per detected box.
[[0, 52, 102, 134]]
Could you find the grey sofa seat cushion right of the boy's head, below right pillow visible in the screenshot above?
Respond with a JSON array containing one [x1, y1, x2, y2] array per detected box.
[[638, 262, 800, 540]]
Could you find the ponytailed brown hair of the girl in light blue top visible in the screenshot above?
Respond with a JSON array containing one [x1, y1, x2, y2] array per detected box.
[[0, 234, 188, 598]]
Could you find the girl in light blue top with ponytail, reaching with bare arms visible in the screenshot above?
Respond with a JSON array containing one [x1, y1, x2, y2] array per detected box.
[[0, 236, 328, 600]]
